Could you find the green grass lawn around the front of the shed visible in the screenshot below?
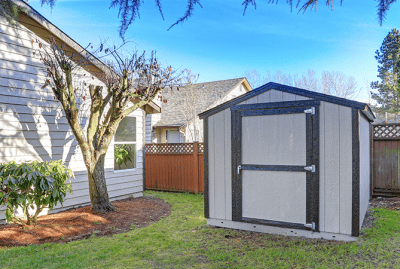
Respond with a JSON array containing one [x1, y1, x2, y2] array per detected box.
[[0, 192, 400, 268]]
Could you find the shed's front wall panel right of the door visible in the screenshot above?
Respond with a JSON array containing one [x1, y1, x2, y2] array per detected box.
[[319, 102, 352, 234]]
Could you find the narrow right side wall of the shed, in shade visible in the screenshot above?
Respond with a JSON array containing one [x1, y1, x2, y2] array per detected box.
[[359, 115, 371, 228]]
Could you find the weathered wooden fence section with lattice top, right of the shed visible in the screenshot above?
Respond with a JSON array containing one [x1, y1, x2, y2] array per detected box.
[[371, 123, 400, 196]]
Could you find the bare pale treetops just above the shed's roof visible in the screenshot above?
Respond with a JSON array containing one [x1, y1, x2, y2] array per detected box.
[[245, 69, 363, 99]]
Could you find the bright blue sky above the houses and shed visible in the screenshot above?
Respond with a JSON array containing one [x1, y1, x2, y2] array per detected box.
[[29, 0, 400, 101]]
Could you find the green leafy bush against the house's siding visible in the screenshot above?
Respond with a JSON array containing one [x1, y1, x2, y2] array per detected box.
[[0, 160, 74, 225]]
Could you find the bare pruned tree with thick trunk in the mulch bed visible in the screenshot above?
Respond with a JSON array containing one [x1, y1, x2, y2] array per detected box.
[[39, 39, 177, 211]]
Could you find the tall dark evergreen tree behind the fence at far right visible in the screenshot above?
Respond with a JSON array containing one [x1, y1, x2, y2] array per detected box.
[[371, 29, 400, 112]]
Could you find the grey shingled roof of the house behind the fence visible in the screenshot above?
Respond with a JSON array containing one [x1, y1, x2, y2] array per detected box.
[[154, 78, 251, 128]]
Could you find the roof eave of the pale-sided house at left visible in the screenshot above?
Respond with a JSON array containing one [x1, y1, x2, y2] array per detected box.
[[13, 0, 161, 113]]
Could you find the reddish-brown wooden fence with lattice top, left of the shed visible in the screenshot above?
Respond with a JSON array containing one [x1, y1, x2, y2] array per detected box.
[[145, 142, 204, 193]]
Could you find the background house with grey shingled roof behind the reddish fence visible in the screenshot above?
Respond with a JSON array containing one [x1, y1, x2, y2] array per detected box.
[[146, 78, 252, 143]]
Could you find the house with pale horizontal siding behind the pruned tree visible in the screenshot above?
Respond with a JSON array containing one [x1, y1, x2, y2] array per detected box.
[[0, 1, 160, 220]]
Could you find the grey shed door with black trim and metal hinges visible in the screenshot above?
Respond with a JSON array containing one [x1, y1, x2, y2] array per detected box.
[[231, 101, 319, 231]]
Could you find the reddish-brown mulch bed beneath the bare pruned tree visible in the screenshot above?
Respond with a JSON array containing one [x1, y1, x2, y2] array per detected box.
[[0, 197, 171, 248]]
